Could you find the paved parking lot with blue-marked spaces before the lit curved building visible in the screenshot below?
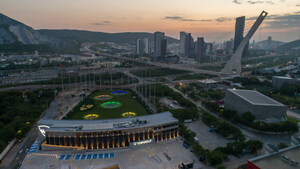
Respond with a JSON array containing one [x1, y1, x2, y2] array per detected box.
[[21, 139, 204, 169]]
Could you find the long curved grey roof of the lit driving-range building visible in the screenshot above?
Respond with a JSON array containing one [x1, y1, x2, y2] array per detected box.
[[38, 112, 178, 132]]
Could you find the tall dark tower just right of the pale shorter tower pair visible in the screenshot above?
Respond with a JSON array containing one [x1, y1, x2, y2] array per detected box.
[[154, 32, 167, 61]]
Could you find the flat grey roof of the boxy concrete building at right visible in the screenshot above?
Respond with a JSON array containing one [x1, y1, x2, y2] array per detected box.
[[228, 89, 284, 106]]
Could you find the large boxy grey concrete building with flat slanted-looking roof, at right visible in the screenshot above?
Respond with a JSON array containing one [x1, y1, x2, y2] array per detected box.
[[225, 89, 287, 122]]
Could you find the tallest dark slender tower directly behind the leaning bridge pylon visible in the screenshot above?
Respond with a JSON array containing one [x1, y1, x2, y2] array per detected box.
[[233, 16, 245, 52]]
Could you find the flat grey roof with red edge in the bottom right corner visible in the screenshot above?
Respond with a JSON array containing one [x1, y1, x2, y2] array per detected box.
[[249, 146, 300, 169]]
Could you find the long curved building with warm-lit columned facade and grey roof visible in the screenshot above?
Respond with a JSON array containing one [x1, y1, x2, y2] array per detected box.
[[38, 112, 178, 150]]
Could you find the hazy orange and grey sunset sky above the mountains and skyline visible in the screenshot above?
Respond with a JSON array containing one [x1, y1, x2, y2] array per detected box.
[[0, 0, 300, 42]]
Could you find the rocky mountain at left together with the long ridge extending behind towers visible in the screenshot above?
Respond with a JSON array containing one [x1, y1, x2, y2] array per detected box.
[[0, 13, 178, 53]]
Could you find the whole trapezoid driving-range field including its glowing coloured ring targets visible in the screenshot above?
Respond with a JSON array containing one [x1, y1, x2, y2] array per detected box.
[[64, 90, 149, 120]]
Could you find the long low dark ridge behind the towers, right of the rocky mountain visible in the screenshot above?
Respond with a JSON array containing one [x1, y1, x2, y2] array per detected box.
[[39, 29, 179, 43]]
